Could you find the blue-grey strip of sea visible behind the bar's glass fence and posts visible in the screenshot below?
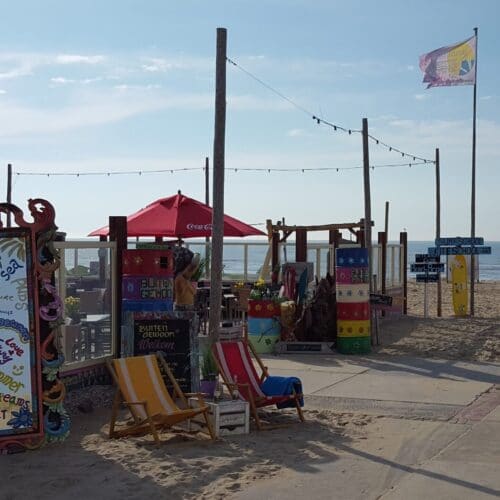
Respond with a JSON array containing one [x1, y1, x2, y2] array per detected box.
[[65, 239, 500, 281]]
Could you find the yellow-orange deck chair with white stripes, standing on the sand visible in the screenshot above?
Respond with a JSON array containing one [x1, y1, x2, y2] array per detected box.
[[108, 353, 215, 444]]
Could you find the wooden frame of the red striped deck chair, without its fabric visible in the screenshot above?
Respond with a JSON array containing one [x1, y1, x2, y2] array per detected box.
[[213, 337, 305, 430]]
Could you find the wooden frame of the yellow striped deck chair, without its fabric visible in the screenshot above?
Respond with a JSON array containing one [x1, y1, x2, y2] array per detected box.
[[107, 353, 216, 445]]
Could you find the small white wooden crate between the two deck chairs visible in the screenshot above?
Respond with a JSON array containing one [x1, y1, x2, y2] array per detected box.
[[189, 398, 250, 437]]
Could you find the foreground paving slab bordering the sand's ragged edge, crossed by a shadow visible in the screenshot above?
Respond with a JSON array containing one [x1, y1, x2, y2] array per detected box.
[[231, 419, 466, 500]]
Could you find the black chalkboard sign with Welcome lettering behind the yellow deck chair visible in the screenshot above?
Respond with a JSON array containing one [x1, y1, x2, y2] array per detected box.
[[134, 318, 191, 392]]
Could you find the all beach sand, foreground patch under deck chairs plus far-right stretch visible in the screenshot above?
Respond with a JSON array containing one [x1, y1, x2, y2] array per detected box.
[[0, 282, 500, 500]]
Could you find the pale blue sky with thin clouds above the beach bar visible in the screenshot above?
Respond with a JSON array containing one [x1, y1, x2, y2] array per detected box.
[[0, 0, 500, 240]]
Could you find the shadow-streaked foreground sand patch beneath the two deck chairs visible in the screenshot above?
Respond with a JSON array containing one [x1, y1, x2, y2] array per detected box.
[[0, 409, 373, 500]]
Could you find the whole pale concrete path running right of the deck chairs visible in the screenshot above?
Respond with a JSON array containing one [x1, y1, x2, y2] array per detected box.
[[234, 355, 500, 500]]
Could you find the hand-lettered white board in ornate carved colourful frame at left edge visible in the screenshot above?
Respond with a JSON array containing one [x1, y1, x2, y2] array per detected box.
[[0, 198, 70, 454]]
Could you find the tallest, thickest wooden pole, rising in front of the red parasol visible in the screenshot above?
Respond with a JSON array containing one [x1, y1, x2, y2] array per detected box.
[[208, 28, 227, 343]]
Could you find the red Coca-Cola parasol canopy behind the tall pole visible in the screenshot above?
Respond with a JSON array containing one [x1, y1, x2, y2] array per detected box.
[[89, 191, 265, 238]]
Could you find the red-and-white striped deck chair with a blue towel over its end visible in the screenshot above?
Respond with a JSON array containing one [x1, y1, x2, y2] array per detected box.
[[212, 339, 304, 430]]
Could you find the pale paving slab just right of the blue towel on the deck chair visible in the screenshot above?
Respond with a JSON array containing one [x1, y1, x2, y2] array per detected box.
[[314, 369, 491, 405]]
